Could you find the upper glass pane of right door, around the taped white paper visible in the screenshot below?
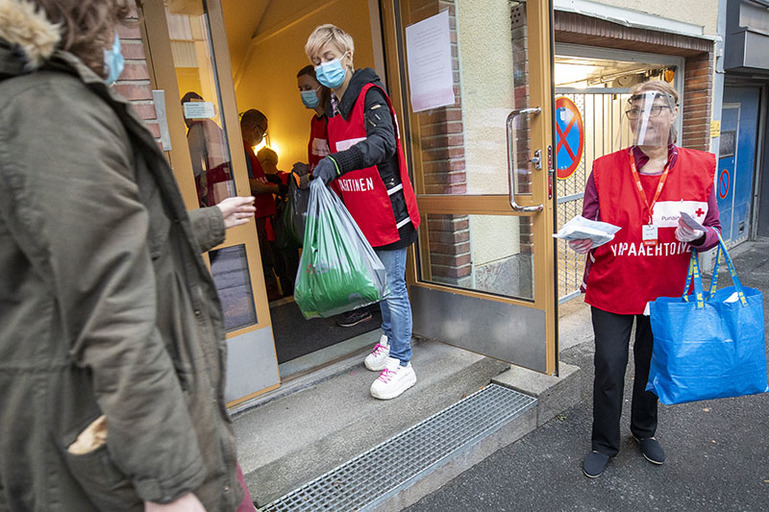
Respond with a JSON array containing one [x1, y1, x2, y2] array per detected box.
[[401, 0, 531, 195]]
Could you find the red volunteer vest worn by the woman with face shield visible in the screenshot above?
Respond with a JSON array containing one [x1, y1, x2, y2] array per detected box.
[[585, 148, 716, 315]]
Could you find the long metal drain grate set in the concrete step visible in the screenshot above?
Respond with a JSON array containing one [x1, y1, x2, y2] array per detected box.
[[261, 384, 537, 512]]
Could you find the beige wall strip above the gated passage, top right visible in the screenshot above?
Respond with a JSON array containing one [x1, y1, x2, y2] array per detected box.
[[596, 0, 718, 36]]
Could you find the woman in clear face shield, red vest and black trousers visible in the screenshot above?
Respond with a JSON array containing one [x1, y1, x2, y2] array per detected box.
[[569, 80, 721, 478]]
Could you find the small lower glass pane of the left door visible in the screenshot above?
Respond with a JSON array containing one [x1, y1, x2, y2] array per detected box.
[[208, 245, 257, 331]]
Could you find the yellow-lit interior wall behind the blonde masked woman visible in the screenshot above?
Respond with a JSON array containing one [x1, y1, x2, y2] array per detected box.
[[225, 0, 374, 171]]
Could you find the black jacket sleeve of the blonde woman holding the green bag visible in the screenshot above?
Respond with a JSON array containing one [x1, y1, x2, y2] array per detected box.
[[331, 87, 395, 175]]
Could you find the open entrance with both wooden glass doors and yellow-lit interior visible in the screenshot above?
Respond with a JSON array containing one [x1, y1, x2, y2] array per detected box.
[[140, 0, 557, 400]]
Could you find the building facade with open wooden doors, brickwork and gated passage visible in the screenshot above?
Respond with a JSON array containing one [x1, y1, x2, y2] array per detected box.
[[116, 0, 752, 409]]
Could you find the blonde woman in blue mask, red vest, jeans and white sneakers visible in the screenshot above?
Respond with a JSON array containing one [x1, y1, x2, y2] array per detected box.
[[304, 24, 420, 400]]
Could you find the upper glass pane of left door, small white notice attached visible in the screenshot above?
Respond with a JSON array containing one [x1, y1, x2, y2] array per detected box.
[[166, 0, 235, 206]]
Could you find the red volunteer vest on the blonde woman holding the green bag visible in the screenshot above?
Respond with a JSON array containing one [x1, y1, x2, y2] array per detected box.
[[328, 84, 420, 247]]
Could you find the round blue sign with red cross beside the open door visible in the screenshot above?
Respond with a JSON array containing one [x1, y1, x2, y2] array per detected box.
[[555, 97, 585, 180]]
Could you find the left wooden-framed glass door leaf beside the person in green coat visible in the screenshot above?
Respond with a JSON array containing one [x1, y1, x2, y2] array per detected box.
[[137, 0, 280, 406]]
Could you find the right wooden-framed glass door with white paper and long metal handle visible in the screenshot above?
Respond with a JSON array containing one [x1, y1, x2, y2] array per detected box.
[[383, 0, 557, 374]]
